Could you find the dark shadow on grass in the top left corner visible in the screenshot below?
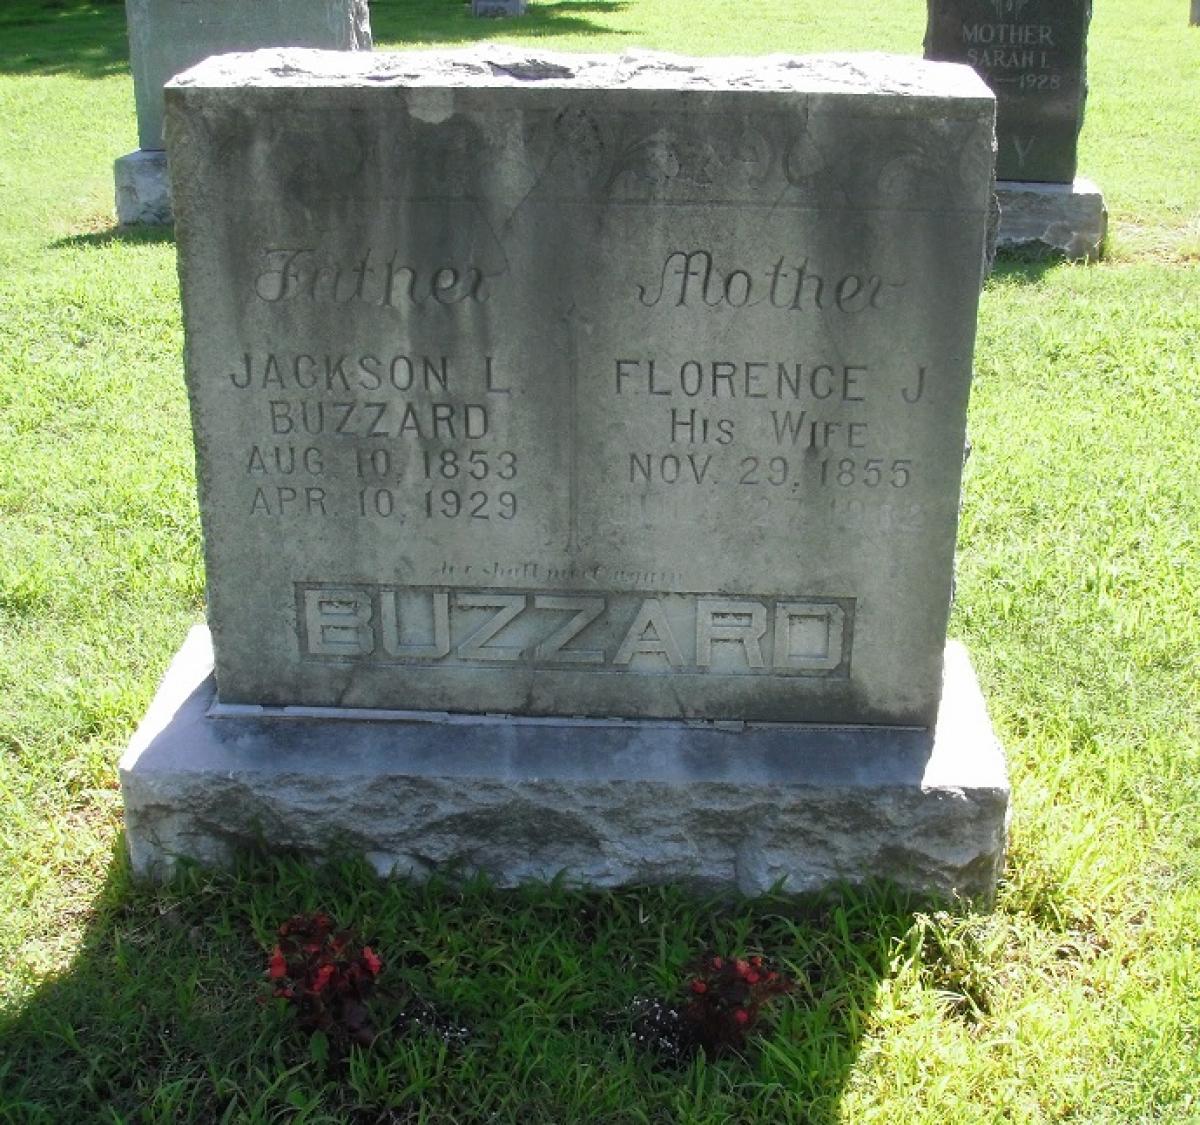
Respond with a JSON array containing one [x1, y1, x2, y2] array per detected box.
[[0, 0, 130, 78]]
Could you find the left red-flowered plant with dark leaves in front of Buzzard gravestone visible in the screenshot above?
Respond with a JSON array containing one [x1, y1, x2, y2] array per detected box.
[[266, 913, 383, 1045]]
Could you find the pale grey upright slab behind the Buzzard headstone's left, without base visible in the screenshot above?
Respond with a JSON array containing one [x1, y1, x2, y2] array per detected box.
[[125, 0, 371, 150]]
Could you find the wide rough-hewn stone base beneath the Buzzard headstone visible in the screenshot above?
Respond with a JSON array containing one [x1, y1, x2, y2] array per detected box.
[[120, 627, 1008, 896]]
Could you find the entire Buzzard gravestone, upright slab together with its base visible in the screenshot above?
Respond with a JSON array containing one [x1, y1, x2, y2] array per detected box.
[[122, 50, 1007, 892]]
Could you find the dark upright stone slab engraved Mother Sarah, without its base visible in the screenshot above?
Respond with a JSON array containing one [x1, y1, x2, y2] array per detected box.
[[925, 0, 1092, 184]]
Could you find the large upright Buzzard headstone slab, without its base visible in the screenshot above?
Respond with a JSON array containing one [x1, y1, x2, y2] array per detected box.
[[167, 52, 994, 726]]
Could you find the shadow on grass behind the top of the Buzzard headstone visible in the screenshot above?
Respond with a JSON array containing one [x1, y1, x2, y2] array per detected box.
[[371, 0, 634, 48]]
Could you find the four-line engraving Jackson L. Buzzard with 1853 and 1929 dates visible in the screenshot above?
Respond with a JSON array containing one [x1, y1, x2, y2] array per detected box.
[[220, 348, 523, 525]]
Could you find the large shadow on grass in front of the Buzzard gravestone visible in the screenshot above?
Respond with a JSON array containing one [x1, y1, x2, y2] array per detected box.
[[0, 844, 964, 1125]]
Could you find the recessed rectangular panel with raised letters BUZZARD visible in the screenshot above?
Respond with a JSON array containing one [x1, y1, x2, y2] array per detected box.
[[296, 583, 854, 678]]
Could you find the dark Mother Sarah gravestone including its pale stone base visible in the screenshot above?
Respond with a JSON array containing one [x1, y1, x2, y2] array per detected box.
[[925, 0, 1108, 258]]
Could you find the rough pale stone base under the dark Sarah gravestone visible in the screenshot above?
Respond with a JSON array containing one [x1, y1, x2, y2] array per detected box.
[[996, 178, 1109, 261]]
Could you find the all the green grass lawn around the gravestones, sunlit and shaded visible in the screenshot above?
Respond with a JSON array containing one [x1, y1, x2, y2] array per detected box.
[[0, 0, 1200, 1125]]
